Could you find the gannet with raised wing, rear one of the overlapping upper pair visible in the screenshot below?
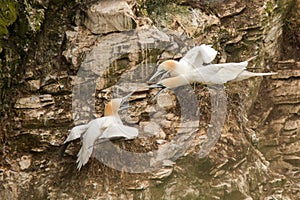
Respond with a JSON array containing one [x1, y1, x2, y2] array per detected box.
[[149, 44, 217, 81]]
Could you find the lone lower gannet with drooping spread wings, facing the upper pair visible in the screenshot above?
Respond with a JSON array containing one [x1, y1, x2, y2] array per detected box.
[[64, 95, 138, 170]]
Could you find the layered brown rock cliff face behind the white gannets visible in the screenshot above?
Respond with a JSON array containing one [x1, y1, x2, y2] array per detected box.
[[0, 0, 300, 199]]
